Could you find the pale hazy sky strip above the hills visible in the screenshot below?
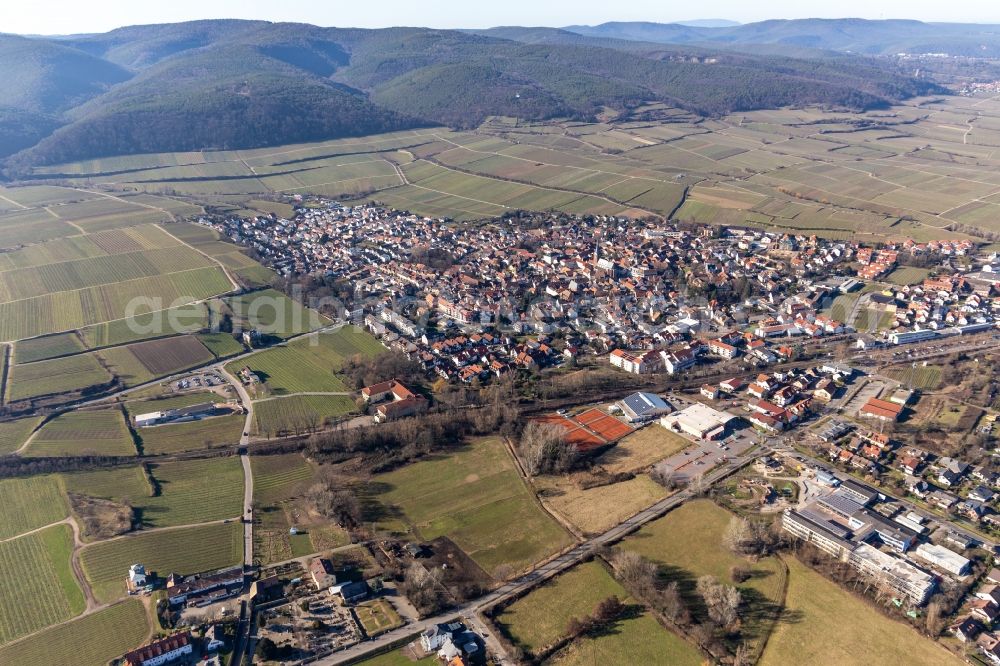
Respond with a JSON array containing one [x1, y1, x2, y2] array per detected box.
[[0, 0, 1000, 34]]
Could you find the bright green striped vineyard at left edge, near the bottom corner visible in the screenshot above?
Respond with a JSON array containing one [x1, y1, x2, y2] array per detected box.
[[0, 525, 86, 644]]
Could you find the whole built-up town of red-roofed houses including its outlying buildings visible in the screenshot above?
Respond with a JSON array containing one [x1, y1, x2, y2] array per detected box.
[[111, 199, 1000, 666]]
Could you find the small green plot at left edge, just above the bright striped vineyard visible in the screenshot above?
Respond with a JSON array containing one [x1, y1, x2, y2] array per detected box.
[[0, 476, 69, 539]]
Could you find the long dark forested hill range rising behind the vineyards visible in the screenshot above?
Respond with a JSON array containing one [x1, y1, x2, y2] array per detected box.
[[0, 20, 938, 173]]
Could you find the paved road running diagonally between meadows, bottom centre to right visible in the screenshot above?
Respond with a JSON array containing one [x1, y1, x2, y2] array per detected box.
[[314, 453, 760, 666]]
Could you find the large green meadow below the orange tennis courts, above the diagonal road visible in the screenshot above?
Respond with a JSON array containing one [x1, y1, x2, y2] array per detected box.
[[372, 438, 570, 573]]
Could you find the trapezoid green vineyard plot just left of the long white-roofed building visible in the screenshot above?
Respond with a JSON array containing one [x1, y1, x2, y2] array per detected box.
[[26, 409, 136, 456]]
